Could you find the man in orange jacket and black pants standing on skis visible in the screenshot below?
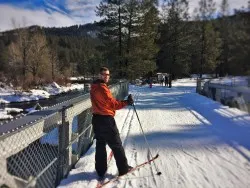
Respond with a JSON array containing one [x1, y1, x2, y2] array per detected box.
[[90, 67, 134, 178]]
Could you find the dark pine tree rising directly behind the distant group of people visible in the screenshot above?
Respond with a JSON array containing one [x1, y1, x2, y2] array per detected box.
[[159, 0, 190, 87]]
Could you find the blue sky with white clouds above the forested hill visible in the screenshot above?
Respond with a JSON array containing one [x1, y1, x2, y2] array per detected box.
[[0, 0, 248, 31]]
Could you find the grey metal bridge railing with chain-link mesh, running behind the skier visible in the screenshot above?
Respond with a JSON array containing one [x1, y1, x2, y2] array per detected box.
[[0, 81, 128, 188]]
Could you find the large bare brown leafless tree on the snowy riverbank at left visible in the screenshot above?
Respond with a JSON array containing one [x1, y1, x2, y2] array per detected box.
[[8, 20, 54, 88]]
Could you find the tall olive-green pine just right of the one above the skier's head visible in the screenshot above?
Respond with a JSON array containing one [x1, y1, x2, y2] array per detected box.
[[126, 0, 159, 78]]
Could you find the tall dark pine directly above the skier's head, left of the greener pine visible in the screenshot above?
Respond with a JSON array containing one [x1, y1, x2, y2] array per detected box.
[[96, 0, 124, 76]]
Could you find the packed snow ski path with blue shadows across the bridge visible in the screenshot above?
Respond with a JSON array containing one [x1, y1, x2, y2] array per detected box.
[[59, 79, 250, 188]]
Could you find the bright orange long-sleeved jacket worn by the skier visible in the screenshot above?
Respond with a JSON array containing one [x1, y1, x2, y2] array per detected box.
[[90, 80, 128, 116]]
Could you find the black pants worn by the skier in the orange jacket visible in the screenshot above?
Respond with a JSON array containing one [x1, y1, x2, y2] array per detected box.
[[92, 114, 128, 176]]
